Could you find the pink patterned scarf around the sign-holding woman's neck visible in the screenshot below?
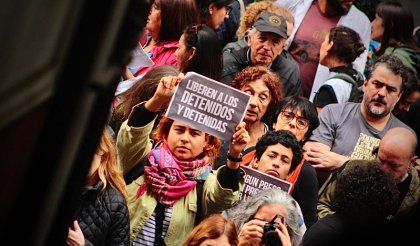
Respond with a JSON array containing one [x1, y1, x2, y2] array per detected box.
[[137, 142, 212, 207]]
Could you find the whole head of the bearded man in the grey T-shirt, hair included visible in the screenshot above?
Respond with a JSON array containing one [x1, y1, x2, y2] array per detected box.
[[362, 55, 408, 119]]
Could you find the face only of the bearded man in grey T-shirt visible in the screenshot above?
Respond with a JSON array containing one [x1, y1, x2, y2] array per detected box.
[[363, 65, 402, 118]]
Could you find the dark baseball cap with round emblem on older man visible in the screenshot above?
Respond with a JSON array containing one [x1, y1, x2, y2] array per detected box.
[[254, 11, 287, 39]]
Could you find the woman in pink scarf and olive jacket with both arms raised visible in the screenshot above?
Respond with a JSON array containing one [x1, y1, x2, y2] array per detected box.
[[117, 76, 249, 245]]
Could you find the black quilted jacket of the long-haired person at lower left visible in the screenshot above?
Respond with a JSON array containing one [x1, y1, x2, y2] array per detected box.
[[74, 181, 130, 245]]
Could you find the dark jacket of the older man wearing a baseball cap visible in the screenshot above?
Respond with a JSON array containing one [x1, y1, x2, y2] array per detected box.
[[221, 39, 302, 97]]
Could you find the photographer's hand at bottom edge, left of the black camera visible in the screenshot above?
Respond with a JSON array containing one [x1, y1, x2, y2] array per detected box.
[[238, 220, 266, 246]]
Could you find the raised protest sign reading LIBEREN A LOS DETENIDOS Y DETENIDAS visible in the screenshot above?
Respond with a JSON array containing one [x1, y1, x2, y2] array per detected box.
[[166, 72, 251, 140]]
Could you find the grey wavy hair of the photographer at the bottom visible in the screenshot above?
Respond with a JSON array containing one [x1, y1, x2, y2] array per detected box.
[[223, 189, 304, 246]]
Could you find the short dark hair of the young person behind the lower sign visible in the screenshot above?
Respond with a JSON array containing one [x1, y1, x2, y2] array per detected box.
[[255, 130, 302, 173]]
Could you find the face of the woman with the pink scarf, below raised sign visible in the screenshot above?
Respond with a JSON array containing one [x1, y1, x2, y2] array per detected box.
[[167, 121, 209, 161]]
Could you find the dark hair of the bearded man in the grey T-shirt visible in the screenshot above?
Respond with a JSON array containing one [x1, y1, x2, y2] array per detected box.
[[366, 55, 409, 92]]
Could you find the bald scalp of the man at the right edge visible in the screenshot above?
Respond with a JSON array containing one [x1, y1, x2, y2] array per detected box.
[[379, 127, 417, 156]]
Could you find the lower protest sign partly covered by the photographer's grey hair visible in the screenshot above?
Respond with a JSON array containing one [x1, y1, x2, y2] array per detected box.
[[239, 166, 292, 200]]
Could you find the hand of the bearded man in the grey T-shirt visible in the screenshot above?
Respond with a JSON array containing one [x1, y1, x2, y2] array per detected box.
[[304, 147, 349, 171]]
